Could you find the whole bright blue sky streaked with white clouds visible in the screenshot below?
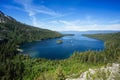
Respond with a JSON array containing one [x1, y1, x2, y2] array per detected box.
[[0, 0, 120, 31]]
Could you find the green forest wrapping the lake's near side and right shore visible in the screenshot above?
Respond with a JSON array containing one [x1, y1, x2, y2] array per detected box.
[[0, 32, 120, 80]]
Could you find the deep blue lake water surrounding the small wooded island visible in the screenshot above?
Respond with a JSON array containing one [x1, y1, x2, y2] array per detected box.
[[21, 34, 104, 59]]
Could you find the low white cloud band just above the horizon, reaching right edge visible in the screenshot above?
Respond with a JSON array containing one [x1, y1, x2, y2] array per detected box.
[[47, 20, 120, 31]]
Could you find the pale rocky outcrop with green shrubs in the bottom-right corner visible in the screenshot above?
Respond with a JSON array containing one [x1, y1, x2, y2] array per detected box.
[[66, 63, 120, 80]]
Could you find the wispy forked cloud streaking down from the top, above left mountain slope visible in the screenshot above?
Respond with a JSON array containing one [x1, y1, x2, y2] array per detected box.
[[15, 0, 63, 26]]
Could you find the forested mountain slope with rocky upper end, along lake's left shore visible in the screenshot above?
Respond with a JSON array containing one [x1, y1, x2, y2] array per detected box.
[[0, 11, 62, 43]]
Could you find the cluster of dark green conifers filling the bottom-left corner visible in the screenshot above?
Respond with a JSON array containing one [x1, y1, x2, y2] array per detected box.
[[0, 55, 24, 80]]
